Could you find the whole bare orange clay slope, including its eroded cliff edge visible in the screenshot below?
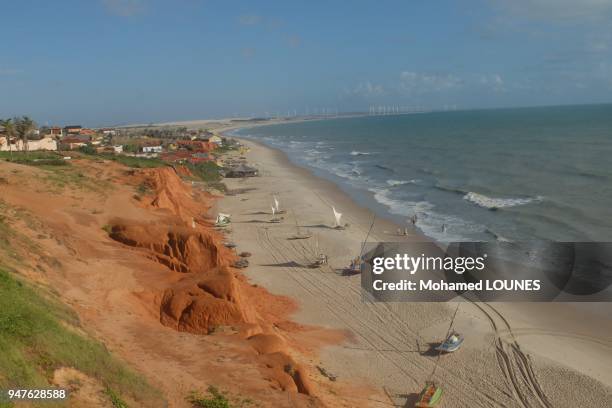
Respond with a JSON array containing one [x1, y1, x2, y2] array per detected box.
[[0, 160, 372, 407]]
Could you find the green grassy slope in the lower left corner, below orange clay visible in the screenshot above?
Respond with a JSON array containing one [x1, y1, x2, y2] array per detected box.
[[0, 269, 164, 407]]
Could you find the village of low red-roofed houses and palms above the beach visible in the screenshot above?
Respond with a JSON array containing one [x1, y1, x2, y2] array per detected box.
[[0, 116, 257, 182]]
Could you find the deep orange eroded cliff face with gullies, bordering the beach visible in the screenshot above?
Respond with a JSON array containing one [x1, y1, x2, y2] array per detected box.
[[109, 168, 313, 395]]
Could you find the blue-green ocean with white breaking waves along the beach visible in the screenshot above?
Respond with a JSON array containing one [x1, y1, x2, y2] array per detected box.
[[236, 105, 612, 242]]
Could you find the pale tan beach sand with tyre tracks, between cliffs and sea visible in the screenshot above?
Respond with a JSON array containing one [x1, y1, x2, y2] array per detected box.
[[219, 135, 612, 407]]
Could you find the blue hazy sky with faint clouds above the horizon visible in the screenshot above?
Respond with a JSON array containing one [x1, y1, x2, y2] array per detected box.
[[0, 0, 612, 126]]
